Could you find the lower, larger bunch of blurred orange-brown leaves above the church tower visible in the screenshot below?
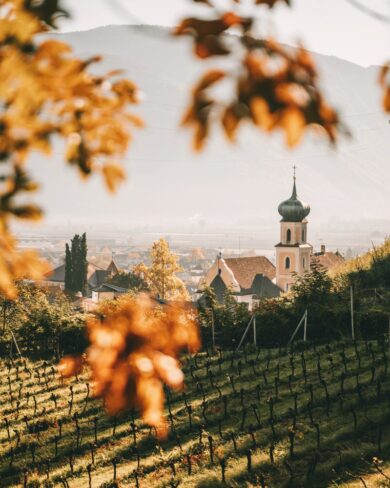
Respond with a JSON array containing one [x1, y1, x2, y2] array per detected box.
[[182, 37, 342, 150]]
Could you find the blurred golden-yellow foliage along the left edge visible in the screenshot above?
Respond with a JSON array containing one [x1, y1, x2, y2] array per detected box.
[[0, 0, 142, 298]]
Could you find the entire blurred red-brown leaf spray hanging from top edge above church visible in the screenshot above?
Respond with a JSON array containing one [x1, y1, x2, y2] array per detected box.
[[175, 1, 346, 150]]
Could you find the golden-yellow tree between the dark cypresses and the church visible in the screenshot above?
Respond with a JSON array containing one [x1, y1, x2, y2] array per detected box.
[[133, 239, 188, 300]]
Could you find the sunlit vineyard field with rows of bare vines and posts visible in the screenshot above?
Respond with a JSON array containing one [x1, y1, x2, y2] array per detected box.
[[0, 342, 390, 488]]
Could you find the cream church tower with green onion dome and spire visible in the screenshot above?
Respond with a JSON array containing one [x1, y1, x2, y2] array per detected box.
[[275, 166, 313, 291]]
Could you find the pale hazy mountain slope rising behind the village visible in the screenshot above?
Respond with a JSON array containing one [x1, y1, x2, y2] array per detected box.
[[24, 26, 390, 242]]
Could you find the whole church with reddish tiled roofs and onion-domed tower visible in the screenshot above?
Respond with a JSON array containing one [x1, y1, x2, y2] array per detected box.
[[198, 172, 344, 309]]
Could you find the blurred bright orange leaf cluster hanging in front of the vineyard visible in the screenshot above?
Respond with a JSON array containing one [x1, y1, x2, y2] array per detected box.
[[60, 295, 200, 435]]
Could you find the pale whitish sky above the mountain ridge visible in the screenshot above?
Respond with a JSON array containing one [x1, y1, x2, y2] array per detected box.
[[61, 0, 390, 66]]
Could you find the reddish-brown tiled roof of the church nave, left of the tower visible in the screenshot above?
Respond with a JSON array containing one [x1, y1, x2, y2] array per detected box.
[[225, 256, 276, 289]]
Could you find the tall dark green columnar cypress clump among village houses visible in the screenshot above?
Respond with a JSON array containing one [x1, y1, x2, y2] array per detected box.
[[65, 233, 88, 293]]
